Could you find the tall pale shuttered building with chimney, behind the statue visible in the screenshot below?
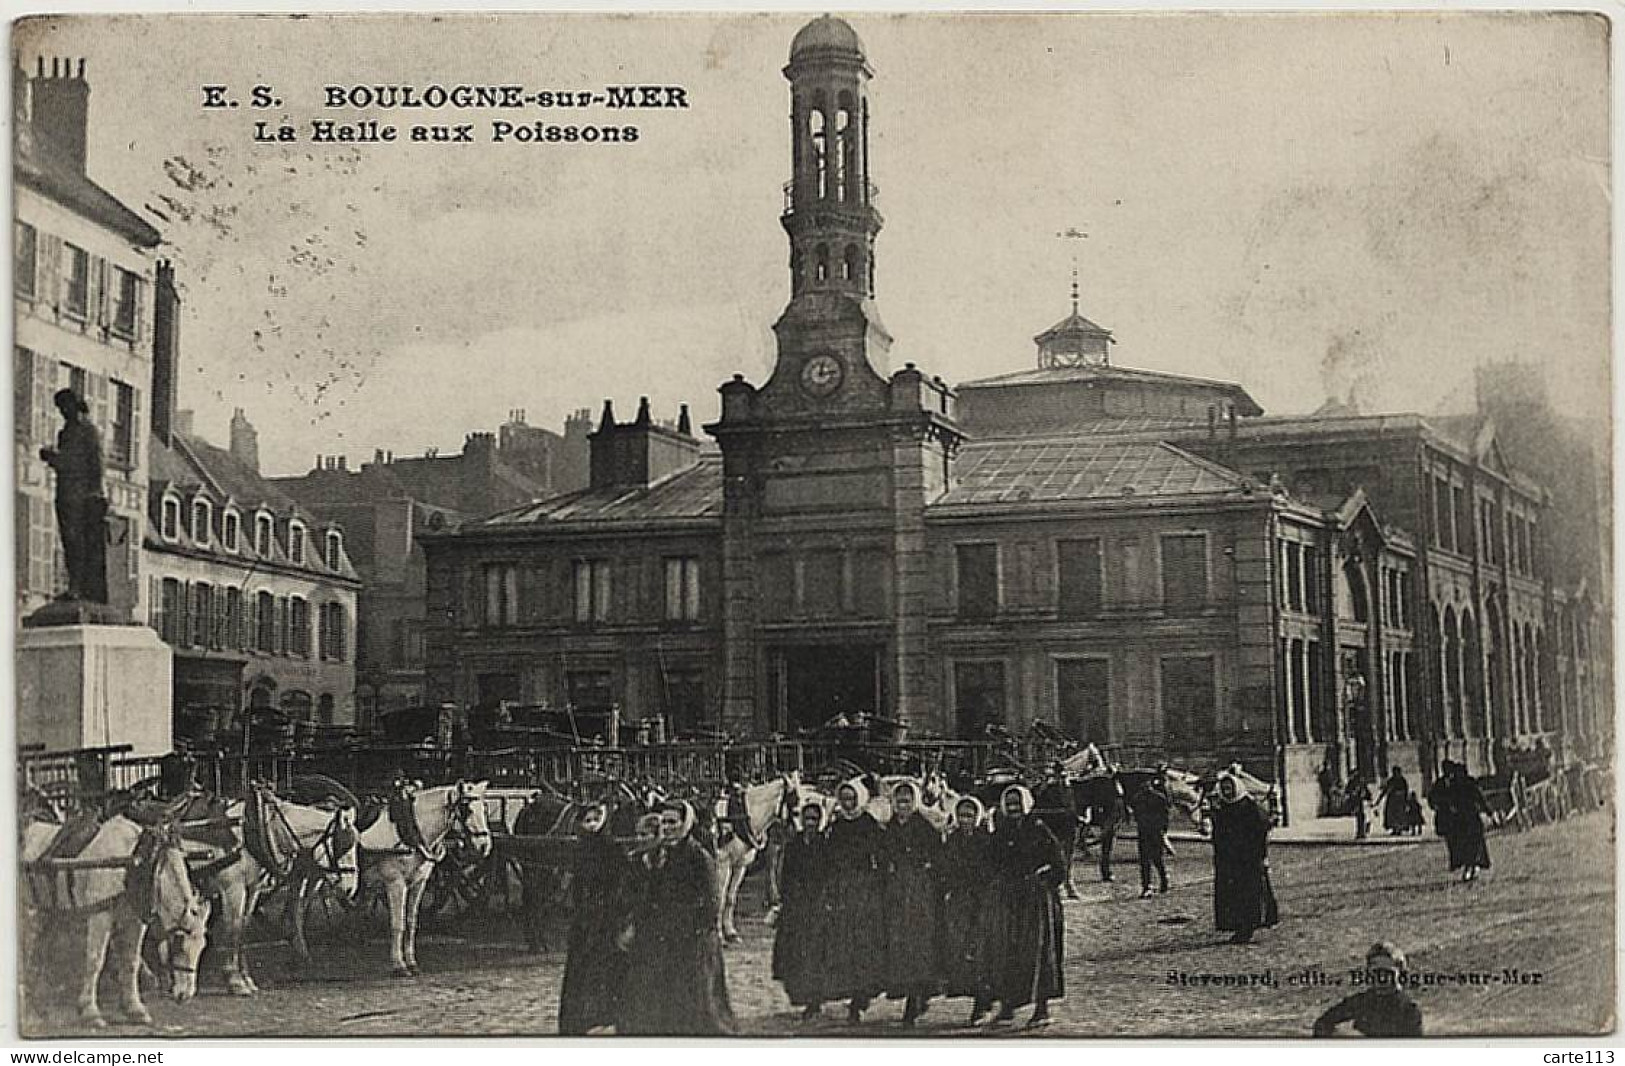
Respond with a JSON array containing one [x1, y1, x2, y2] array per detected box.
[[11, 59, 160, 618]]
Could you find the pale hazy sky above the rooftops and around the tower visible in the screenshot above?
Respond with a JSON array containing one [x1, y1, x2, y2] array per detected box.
[[15, 13, 1610, 475]]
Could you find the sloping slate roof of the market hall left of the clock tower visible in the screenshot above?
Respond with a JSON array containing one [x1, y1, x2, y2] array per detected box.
[[462, 455, 722, 530]]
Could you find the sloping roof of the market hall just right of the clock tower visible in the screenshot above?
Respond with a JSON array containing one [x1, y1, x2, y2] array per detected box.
[[933, 436, 1246, 507]]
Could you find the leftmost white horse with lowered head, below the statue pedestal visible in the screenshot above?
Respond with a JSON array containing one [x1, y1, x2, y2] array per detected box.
[[23, 814, 210, 1029]]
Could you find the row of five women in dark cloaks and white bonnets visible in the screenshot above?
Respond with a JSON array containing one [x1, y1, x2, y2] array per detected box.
[[774, 780, 1066, 1027]]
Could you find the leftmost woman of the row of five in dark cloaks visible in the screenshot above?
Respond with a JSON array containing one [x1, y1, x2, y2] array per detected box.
[[774, 801, 830, 1021]]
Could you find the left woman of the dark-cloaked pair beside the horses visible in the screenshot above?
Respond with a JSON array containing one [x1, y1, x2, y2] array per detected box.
[[559, 803, 631, 1037]]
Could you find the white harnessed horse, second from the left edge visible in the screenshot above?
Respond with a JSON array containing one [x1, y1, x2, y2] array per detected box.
[[182, 791, 361, 996]]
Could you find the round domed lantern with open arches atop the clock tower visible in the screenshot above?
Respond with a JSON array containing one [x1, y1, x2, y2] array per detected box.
[[780, 15, 881, 299]]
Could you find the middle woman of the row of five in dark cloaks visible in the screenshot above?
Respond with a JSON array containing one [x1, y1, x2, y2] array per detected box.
[[881, 782, 943, 1025]]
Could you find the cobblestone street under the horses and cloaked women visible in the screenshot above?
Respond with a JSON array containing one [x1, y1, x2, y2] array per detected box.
[[25, 814, 1614, 1037]]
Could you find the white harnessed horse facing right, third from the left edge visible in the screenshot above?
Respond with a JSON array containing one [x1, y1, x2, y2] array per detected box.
[[361, 782, 491, 977]]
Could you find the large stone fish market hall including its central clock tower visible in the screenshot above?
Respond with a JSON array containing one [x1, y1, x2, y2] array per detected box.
[[424, 16, 1610, 817]]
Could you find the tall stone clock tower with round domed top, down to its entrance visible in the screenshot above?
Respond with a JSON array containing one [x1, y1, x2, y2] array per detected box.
[[705, 15, 962, 735]]
